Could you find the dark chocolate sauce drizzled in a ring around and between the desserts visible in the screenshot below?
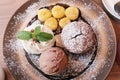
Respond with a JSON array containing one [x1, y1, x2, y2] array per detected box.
[[25, 3, 97, 80]]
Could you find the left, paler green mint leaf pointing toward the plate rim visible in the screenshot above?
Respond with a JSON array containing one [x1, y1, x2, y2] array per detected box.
[[17, 31, 32, 40]]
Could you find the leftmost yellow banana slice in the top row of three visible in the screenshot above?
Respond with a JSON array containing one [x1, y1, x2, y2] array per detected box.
[[38, 8, 52, 21]]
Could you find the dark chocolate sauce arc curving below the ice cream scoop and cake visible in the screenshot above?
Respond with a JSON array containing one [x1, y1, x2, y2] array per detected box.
[[25, 46, 97, 80]]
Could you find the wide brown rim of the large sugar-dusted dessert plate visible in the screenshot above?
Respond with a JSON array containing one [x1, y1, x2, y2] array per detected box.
[[3, 0, 116, 80]]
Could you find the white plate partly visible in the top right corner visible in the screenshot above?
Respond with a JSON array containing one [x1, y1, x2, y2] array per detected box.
[[102, 0, 120, 21]]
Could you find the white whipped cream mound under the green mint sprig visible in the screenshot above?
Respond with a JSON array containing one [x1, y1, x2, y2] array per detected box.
[[21, 20, 55, 54]]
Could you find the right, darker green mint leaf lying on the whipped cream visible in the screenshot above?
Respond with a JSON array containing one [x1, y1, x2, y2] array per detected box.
[[36, 32, 53, 42]]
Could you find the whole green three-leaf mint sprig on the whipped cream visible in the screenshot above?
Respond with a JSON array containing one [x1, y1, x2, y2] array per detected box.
[[17, 26, 53, 42]]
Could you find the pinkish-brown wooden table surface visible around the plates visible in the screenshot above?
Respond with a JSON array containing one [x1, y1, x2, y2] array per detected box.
[[0, 0, 120, 80]]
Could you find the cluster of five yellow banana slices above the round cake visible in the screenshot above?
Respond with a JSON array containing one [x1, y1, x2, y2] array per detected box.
[[38, 5, 79, 31]]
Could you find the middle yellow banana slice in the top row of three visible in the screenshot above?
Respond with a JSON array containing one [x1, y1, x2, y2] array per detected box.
[[52, 5, 65, 18]]
